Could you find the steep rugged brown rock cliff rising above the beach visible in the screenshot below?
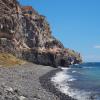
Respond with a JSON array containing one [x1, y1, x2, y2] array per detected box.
[[0, 0, 82, 66]]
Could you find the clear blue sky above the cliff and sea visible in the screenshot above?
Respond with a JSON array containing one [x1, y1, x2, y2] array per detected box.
[[19, 0, 100, 62]]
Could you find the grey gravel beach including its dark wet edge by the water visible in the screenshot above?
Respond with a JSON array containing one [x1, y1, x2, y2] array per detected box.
[[0, 63, 73, 100]]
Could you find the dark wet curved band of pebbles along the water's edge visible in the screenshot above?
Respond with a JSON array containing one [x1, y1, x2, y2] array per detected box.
[[39, 68, 76, 100]]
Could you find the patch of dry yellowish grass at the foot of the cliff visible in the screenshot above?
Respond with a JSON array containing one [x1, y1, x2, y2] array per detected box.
[[0, 53, 25, 67]]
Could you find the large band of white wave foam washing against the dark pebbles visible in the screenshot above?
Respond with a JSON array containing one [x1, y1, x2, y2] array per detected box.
[[51, 69, 91, 100]]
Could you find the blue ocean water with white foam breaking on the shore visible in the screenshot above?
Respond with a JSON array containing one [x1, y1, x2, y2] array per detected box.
[[51, 63, 100, 100]]
